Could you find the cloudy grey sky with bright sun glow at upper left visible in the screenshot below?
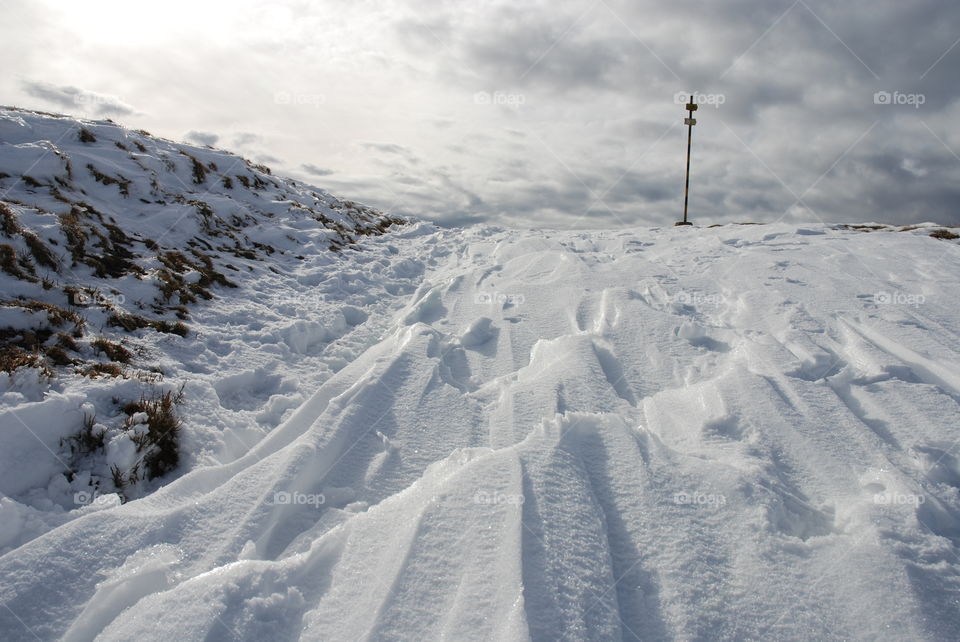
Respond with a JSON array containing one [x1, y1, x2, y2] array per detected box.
[[0, 0, 960, 228]]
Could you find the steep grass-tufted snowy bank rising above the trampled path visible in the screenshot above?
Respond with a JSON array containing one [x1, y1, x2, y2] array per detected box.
[[0, 108, 402, 366]]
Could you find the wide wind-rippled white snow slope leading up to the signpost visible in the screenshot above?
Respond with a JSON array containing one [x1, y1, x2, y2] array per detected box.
[[0, 214, 960, 640]]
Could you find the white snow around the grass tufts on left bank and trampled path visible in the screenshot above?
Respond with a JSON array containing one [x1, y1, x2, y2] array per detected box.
[[0, 109, 408, 516]]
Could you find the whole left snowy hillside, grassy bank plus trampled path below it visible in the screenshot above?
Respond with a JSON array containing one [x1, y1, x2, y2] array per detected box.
[[0, 108, 408, 536]]
